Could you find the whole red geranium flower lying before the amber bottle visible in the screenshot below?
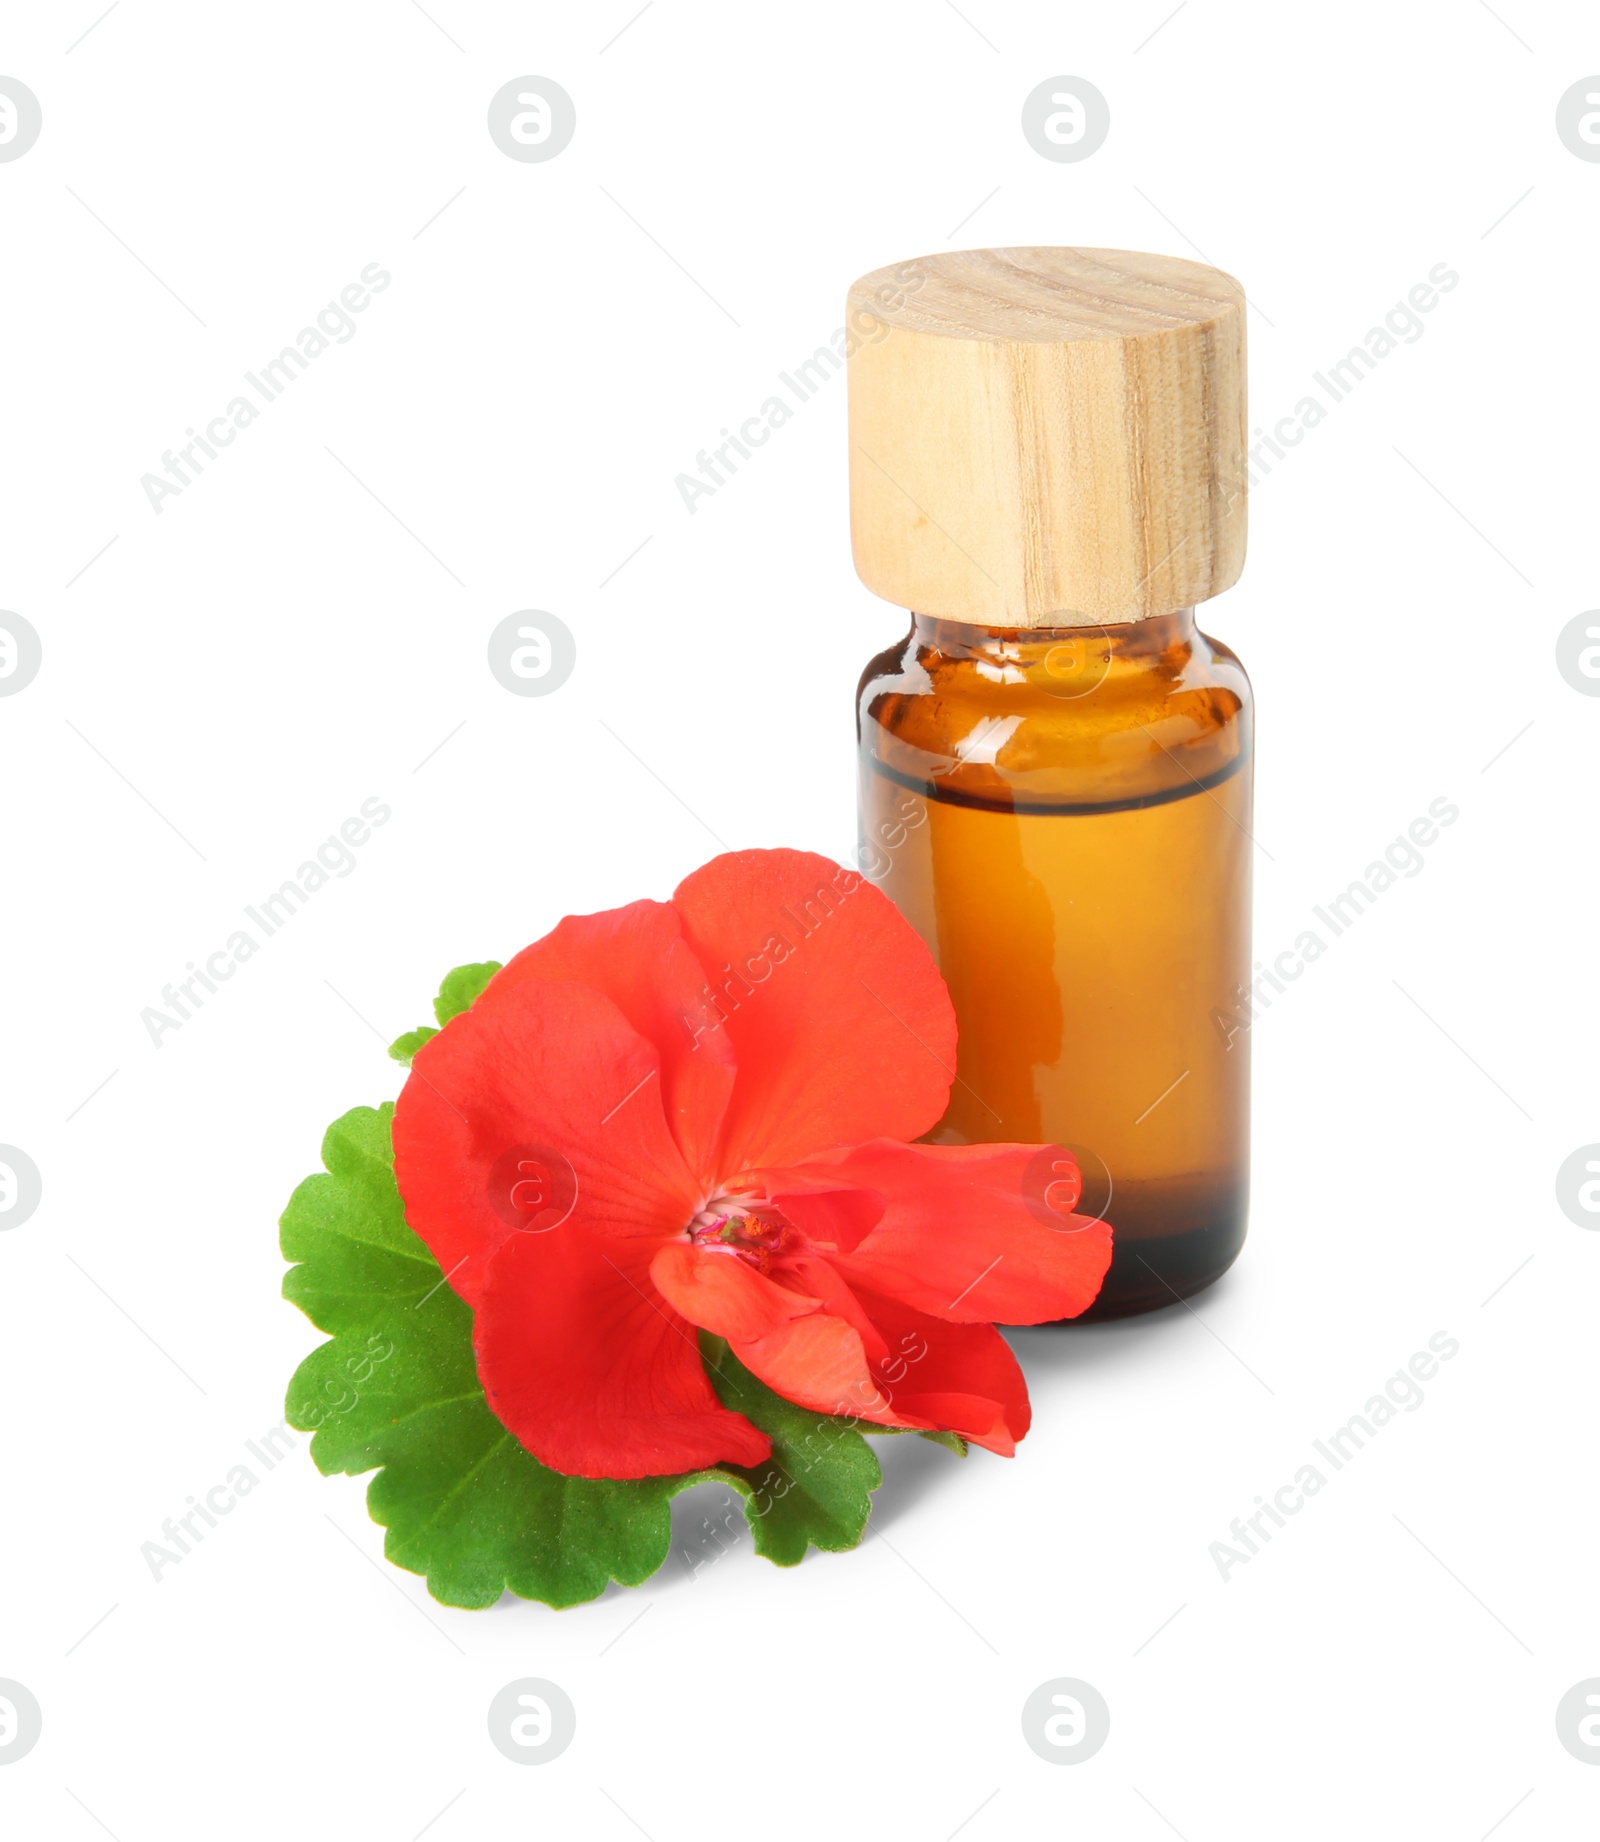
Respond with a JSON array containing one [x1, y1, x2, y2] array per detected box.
[[394, 851, 1110, 1477]]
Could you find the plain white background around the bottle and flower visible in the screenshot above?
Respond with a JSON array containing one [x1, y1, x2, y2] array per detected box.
[[0, 0, 1600, 1842]]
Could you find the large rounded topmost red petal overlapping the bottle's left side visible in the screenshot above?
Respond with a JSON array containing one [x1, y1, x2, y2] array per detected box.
[[672, 851, 956, 1179]]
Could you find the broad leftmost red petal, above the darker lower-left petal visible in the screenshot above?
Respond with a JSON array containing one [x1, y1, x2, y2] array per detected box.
[[394, 980, 703, 1306]]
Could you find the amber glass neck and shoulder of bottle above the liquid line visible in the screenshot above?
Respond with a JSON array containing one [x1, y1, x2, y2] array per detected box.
[[856, 615, 1254, 807]]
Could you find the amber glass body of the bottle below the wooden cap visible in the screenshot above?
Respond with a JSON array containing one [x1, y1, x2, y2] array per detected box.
[[862, 617, 1252, 1317]]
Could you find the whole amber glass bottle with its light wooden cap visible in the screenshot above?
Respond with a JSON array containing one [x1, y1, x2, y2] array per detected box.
[[851, 251, 1252, 1317]]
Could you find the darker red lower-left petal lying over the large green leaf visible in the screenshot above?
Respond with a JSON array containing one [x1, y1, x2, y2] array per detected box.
[[475, 1223, 771, 1477]]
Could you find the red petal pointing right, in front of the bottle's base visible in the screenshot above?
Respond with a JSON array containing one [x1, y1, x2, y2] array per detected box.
[[762, 1138, 1112, 1324]]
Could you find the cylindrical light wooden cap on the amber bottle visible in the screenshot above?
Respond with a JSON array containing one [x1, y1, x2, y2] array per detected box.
[[845, 249, 1246, 626]]
